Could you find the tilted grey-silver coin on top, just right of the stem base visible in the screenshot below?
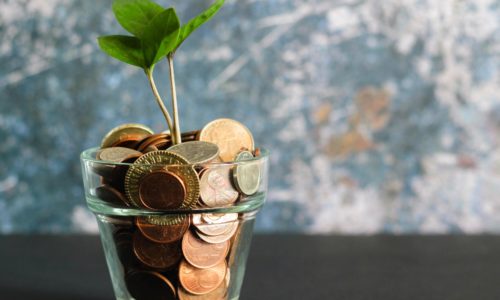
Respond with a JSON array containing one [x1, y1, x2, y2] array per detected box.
[[168, 141, 219, 164]]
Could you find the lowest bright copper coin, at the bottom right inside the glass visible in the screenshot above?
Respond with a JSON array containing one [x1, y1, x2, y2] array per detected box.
[[179, 260, 227, 295]]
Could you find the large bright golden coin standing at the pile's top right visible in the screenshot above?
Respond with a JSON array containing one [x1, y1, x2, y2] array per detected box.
[[198, 119, 254, 162]]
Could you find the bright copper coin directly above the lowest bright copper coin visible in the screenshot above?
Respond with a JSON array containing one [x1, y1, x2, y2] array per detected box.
[[182, 230, 230, 269]]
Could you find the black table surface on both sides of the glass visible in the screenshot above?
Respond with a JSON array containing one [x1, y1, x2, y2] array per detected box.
[[0, 235, 500, 300]]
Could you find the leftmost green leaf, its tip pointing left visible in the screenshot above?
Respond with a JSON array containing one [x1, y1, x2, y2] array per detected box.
[[98, 35, 145, 68]]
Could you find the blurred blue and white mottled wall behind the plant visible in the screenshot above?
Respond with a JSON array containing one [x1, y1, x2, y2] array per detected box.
[[0, 0, 500, 233]]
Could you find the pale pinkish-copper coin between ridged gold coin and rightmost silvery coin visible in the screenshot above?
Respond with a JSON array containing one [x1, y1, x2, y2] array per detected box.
[[200, 166, 239, 207]]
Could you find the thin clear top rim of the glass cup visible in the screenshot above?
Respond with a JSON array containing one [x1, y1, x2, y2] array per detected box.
[[80, 147, 269, 168]]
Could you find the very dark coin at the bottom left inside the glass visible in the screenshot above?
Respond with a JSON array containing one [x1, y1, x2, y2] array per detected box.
[[125, 271, 177, 300]]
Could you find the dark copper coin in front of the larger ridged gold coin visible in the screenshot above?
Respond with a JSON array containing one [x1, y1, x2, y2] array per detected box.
[[139, 171, 186, 209]]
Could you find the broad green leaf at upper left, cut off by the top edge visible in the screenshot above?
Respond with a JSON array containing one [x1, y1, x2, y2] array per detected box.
[[113, 0, 165, 38]]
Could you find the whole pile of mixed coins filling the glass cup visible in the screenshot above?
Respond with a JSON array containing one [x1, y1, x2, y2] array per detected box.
[[94, 119, 261, 300]]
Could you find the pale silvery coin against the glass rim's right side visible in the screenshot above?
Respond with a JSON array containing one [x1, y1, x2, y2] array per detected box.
[[233, 151, 261, 196]]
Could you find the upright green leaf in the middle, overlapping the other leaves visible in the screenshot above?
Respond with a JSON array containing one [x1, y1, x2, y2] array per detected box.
[[141, 8, 181, 68]]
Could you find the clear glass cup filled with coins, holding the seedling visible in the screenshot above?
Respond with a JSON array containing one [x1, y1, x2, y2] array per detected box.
[[81, 148, 268, 300]]
